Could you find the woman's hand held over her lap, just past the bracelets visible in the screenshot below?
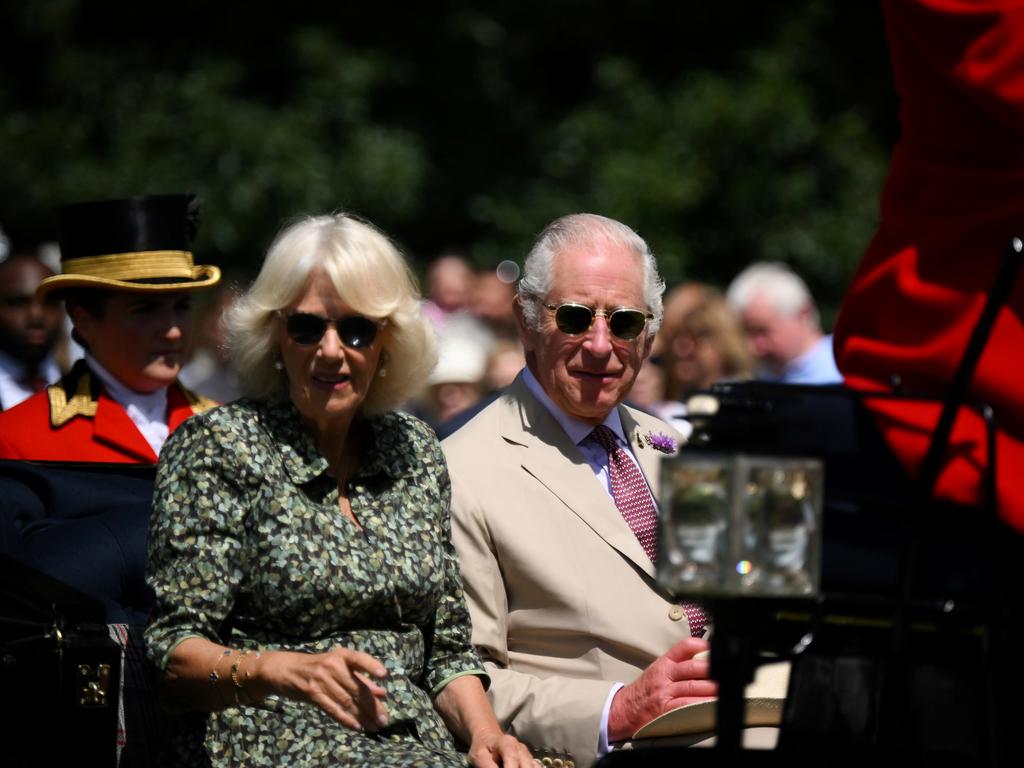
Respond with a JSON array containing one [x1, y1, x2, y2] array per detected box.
[[246, 646, 388, 731]]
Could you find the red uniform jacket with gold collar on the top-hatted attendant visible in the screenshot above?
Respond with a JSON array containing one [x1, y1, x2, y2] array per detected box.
[[0, 361, 217, 464]]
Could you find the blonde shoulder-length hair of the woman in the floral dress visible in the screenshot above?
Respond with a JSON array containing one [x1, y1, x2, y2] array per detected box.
[[224, 213, 437, 414]]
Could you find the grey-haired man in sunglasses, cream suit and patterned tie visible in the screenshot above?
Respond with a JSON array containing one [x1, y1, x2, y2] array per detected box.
[[443, 214, 716, 765]]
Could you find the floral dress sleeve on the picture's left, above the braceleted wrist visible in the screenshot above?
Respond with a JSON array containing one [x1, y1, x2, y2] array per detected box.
[[145, 417, 247, 670]]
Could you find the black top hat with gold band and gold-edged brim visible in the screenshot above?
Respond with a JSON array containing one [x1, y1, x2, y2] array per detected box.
[[37, 195, 220, 296]]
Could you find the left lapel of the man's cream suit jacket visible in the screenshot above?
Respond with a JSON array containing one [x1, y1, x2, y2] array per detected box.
[[500, 377, 654, 575]]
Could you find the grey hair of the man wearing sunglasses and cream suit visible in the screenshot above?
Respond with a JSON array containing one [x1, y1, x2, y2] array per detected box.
[[517, 213, 665, 336]]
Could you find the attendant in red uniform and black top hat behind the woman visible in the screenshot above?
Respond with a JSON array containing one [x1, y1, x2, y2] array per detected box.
[[0, 195, 220, 464]]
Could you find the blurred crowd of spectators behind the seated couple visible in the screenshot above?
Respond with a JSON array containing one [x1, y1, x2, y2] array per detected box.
[[0, 221, 841, 434]]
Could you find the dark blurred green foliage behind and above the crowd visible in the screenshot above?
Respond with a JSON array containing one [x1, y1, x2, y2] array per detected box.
[[0, 0, 896, 321]]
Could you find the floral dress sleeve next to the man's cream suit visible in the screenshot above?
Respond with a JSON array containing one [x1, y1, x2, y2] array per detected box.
[[415, 438, 489, 696]]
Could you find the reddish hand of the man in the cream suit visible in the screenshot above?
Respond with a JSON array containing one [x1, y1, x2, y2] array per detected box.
[[608, 637, 718, 741]]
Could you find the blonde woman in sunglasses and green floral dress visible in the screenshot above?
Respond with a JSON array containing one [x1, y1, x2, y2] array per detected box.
[[146, 214, 532, 767]]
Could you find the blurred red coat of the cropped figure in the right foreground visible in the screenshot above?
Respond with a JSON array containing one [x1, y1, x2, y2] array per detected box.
[[835, 0, 1024, 529]]
